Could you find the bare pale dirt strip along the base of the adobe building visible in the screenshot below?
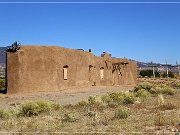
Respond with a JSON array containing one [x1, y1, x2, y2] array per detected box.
[[0, 86, 133, 109]]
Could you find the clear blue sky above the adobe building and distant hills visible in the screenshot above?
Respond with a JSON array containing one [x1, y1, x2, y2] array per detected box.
[[0, 0, 180, 64]]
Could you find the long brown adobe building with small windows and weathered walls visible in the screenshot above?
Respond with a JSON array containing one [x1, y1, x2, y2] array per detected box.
[[6, 46, 137, 94]]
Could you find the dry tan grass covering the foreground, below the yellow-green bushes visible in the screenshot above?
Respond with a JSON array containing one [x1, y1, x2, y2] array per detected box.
[[0, 79, 180, 134]]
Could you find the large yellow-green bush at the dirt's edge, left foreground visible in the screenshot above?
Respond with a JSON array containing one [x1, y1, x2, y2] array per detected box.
[[18, 101, 60, 117]]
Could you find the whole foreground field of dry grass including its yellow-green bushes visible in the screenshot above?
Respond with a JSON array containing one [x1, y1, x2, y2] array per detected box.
[[0, 80, 180, 134]]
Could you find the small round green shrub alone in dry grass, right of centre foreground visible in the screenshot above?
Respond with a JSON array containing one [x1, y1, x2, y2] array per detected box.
[[114, 109, 130, 119]]
